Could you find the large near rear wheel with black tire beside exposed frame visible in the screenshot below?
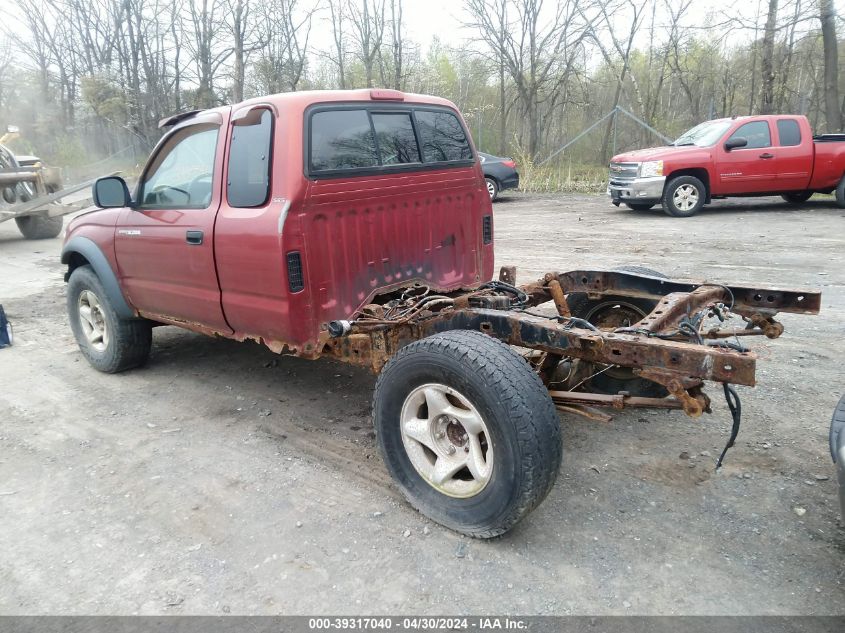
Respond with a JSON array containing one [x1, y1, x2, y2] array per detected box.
[[373, 330, 561, 538]]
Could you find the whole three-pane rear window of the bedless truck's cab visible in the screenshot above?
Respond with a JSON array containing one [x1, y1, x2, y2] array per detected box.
[[306, 103, 475, 177]]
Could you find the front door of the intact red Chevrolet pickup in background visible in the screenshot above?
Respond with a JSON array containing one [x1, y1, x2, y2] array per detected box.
[[716, 121, 777, 194]]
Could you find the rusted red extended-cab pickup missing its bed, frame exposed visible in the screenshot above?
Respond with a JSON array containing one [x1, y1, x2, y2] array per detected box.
[[62, 90, 820, 537]]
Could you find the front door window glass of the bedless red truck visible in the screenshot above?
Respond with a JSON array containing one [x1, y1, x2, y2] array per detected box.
[[138, 124, 220, 209]]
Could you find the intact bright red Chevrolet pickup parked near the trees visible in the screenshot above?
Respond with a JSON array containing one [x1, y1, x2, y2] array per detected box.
[[607, 115, 845, 218]]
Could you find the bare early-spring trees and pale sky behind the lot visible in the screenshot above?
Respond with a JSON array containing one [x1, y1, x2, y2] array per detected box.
[[0, 0, 845, 178]]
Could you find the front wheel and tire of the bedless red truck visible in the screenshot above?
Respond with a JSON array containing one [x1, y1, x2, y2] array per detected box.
[[67, 266, 152, 374]]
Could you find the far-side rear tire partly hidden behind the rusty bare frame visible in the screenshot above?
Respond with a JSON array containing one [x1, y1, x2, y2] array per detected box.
[[566, 266, 669, 398]]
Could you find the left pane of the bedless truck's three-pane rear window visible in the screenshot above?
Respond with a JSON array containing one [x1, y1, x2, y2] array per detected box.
[[311, 110, 378, 171]]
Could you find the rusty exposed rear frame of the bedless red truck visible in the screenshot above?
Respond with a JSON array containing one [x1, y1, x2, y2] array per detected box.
[[323, 267, 821, 417]]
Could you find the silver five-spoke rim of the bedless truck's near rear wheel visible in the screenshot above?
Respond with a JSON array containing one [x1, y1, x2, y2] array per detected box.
[[400, 383, 493, 498]]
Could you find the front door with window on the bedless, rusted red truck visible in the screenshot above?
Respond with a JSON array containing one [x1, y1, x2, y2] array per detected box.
[[114, 111, 231, 333]]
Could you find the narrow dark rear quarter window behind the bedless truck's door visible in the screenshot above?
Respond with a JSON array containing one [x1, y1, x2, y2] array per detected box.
[[226, 108, 273, 208]]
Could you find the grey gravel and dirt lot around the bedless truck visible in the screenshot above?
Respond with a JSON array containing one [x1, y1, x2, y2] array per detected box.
[[0, 195, 845, 614]]
